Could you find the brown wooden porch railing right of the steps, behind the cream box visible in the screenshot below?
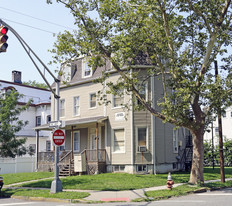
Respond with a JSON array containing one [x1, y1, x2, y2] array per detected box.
[[82, 149, 106, 162]]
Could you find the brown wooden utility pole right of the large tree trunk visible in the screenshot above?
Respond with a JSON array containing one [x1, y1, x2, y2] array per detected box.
[[214, 61, 225, 183]]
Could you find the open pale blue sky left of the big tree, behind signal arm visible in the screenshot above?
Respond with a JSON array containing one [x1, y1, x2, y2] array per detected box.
[[0, 0, 75, 84]]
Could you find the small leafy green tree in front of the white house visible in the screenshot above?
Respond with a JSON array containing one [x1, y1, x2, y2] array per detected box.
[[0, 90, 29, 158]]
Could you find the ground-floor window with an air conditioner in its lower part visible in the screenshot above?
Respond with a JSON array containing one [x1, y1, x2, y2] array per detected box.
[[136, 126, 148, 152]]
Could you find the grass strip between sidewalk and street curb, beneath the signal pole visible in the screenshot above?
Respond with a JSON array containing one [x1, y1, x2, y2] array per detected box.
[[2, 189, 89, 200]]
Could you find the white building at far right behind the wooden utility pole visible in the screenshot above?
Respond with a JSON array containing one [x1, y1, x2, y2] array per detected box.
[[204, 107, 232, 146]]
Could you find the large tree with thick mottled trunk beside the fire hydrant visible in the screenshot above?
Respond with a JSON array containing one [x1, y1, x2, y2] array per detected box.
[[47, 0, 232, 184]]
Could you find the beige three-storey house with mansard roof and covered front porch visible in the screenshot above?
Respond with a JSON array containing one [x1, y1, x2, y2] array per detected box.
[[36, 58, 192, 174]]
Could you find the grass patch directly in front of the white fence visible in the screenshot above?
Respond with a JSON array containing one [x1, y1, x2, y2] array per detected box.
[[0, 172, 54, 185]]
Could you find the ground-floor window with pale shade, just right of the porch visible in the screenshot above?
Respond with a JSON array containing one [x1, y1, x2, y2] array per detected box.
[[113, 129, 125, 152]]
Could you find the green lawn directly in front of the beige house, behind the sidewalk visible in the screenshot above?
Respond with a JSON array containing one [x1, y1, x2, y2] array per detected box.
[[15, 168, 232, 191]]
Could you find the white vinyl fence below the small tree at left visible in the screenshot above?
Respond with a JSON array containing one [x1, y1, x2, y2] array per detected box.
[[0, 157, 36, 174]]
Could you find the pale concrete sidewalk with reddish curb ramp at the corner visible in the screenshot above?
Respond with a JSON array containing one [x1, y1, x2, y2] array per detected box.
[[4, 178, 232, 202]]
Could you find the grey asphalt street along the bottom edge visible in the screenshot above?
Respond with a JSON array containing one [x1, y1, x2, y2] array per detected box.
[[0, 188, 232, 206]]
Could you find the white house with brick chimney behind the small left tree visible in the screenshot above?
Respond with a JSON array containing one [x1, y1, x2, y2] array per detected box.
[[0, 71, 51, 156]]
